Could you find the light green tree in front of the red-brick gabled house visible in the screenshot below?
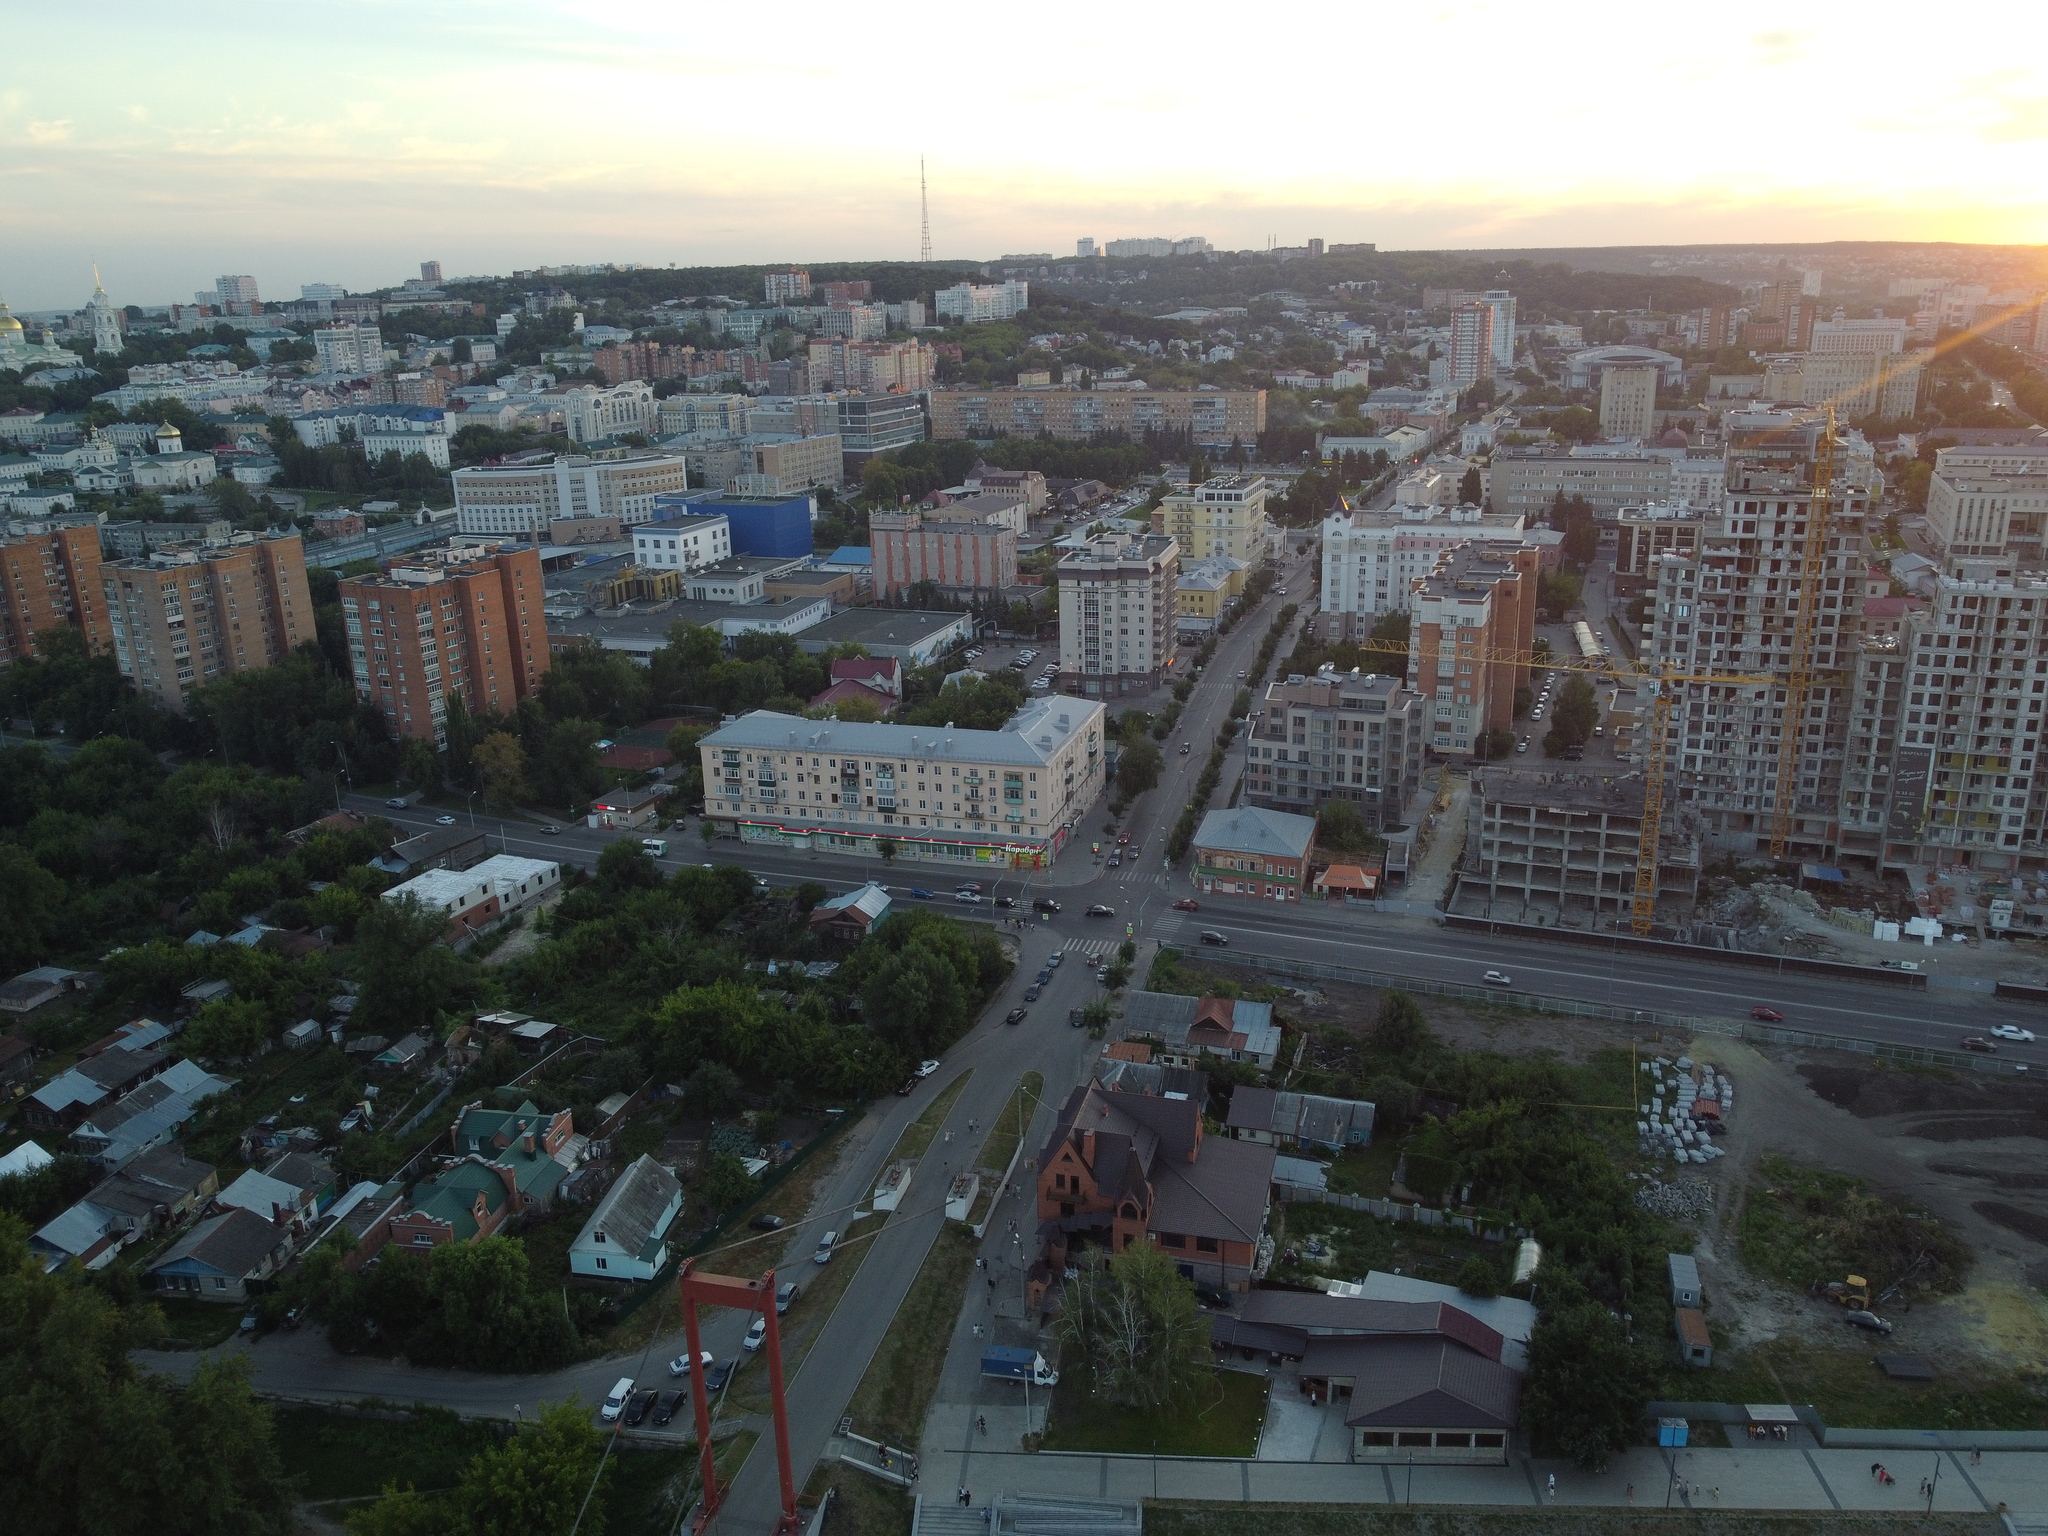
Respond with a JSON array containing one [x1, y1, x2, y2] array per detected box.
[[1057, 1243, 1214, 1413]]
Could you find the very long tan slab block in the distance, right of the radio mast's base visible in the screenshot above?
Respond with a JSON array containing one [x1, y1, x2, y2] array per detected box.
[[930, 387, 1266, 449]]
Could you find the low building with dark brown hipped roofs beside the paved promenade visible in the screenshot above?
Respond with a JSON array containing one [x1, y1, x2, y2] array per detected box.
[[1210, 1290, 1522, 1466]]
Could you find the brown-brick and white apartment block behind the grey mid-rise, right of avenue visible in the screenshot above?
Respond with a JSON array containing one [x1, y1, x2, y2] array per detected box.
[[1407, 545, 1538, 756]]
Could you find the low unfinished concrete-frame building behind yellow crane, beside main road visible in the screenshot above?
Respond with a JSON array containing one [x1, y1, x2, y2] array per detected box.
[[1450, 768, 1702, 926]]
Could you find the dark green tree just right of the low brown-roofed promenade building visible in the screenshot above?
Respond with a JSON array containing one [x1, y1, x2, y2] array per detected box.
[[1522, 1302, 1655, 1473]]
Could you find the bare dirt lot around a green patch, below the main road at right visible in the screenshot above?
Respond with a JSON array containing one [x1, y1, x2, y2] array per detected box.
[[1280, 983, 2048, 1391]]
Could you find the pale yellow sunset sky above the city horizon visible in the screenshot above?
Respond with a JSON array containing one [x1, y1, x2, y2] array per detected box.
[[0, 0, 2048, 313]]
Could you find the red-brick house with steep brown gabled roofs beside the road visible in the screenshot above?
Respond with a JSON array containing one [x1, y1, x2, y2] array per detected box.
[[1028, 1083, 1274, 1305]]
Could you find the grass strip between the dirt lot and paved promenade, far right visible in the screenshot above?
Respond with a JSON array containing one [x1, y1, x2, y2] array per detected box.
[[1657, 1343, 2048, 1430]]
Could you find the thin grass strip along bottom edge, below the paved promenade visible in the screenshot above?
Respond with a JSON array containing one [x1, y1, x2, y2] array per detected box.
[[1146, 1499, 2005, 1536]]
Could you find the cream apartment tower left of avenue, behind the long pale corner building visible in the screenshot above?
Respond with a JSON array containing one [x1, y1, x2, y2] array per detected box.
[[1059, 532, 1180, 698]]
